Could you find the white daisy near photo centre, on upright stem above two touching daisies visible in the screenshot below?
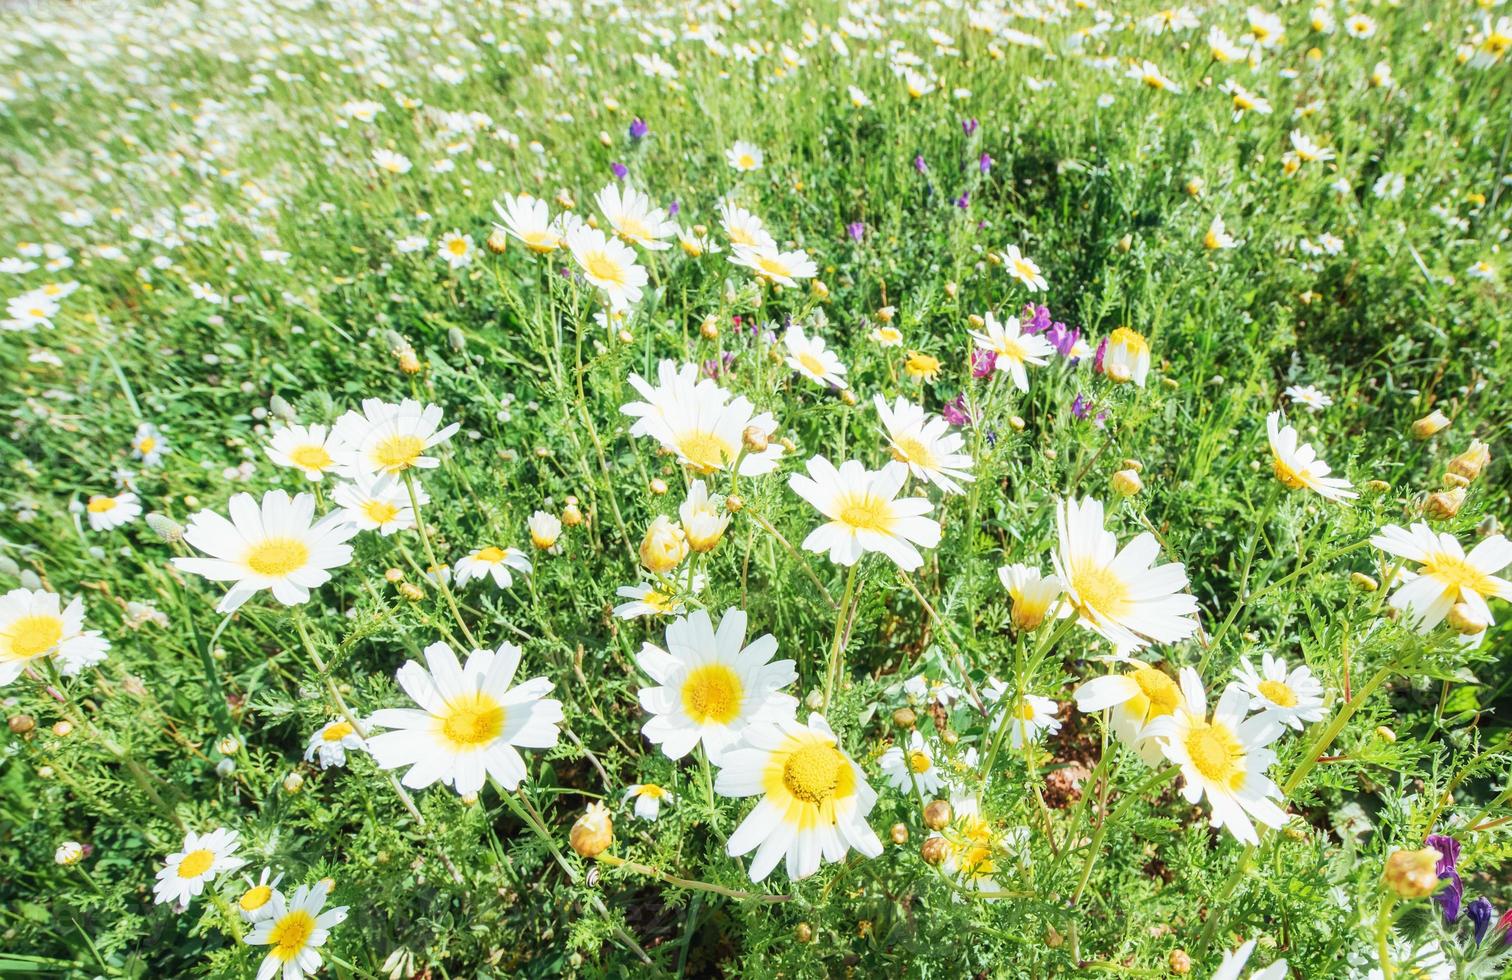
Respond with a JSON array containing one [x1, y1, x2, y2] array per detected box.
[[788, 455, 940, 572]]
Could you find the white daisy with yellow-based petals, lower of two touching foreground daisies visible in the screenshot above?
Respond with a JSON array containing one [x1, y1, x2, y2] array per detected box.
[[714, 714, 881, 882]]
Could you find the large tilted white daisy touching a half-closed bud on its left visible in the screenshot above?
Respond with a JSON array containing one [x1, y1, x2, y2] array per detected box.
[[1052, 498, 1198, 656]]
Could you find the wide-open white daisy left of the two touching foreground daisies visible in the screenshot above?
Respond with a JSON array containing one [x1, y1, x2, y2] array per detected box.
[[367, 643, 562, 795]]
